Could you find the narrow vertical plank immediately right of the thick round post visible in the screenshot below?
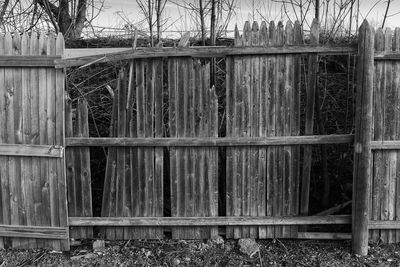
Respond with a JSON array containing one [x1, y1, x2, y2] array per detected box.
[[370, 29, 385, 245]]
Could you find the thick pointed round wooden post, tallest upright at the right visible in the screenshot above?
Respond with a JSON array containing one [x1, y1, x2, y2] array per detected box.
[[352, 20, 374, 256]]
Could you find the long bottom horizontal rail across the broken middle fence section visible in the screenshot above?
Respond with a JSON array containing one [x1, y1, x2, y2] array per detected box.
[[69, 215, 351, 226]]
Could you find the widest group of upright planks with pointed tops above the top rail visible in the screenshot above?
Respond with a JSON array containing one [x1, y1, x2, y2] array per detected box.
[[226, 22, 301, 238]]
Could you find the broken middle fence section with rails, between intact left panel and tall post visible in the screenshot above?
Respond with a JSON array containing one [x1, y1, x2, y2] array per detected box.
[[67, 21, 354, 243]]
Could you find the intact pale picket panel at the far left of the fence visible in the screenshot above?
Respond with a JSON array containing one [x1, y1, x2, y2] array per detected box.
[[0, 33, 69, 250]]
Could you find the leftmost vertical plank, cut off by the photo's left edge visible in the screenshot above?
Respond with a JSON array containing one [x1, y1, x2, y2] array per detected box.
[[0, 34, 5, 249]]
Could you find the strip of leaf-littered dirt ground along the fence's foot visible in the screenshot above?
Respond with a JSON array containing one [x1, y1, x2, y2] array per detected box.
[[0, 239, 400, 267]]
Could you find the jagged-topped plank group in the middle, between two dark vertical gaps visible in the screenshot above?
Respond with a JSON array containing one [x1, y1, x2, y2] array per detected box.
[[168, 58, 218, 239]]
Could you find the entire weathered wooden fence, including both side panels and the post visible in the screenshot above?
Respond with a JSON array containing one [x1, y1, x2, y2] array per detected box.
[[0, 19, 400, 254]]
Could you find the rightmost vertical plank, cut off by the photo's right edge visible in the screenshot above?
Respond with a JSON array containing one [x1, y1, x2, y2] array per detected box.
[[393, 27, 400, 243]]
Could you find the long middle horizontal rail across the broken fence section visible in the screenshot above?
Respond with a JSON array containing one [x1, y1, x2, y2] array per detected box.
[[65, 134, 354, 147]]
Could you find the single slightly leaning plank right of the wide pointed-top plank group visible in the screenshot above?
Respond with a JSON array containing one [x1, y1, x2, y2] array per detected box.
[[300, 19, 319, 220]]
